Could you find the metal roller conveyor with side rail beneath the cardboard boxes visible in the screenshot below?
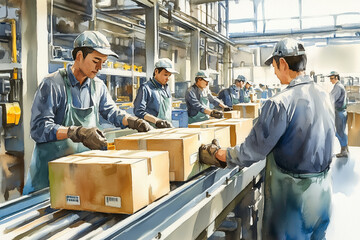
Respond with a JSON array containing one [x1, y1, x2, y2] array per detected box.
[[0, 161, 265, 239]]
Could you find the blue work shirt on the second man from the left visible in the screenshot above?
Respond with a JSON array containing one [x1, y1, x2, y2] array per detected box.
[[134, 78, 171, 119]]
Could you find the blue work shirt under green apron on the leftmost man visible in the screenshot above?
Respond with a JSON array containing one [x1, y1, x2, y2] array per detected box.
[[30, 64, 126, 143]]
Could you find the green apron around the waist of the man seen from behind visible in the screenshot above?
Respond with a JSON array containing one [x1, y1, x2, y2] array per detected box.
[[262, 154, 331, 239]]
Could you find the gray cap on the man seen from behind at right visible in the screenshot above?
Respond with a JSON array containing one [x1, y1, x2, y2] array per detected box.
[[265, 38, 305, 66]]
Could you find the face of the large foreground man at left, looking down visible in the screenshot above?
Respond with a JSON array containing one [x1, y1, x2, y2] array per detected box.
[[76, 51, 108, 78]]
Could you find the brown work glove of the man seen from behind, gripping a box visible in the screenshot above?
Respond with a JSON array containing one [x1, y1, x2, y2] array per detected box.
[[199, 139, 226, 168]]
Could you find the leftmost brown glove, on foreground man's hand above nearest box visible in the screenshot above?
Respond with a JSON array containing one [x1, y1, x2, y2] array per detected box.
[[67, 126, 107, 150]]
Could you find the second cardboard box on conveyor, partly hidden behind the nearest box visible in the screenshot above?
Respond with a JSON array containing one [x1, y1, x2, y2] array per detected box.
[[114, 133, 201, 181]]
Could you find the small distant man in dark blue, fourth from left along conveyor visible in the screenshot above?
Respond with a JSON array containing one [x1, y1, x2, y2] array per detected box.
[[218, 75, 246, 107]]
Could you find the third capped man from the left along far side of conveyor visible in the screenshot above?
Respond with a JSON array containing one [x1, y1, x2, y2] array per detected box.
[[185, 70, 229, 124]]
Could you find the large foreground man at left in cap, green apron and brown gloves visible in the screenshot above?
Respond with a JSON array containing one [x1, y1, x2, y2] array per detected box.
[[23, 31, 151, 194]]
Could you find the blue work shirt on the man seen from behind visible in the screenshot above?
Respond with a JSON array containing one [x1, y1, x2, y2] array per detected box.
[[227, 76, 335, 173]]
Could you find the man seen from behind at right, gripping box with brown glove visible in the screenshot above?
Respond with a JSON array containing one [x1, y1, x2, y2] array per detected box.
[[199, 38, 335, 239]]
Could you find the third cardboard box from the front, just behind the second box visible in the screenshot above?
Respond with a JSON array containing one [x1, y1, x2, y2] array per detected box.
[[208, 118, 253, 147]]
